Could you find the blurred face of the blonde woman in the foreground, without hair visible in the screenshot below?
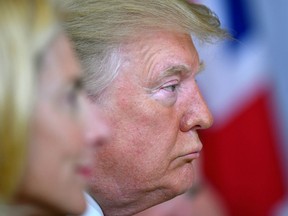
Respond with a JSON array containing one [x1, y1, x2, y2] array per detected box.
[[16, 35, 108, 215]]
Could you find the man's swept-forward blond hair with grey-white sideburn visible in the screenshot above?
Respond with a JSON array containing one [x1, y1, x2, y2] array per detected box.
[[64, 0, 226, 98]]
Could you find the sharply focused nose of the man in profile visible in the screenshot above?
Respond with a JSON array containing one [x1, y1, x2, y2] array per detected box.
[[180, 86, 213, 132]]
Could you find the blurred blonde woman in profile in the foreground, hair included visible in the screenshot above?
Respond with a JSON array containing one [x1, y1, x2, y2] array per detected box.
[[0, 0, 108, 216]]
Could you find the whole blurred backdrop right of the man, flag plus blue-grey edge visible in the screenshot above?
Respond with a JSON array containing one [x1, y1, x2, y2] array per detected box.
[[196, 0, 288, 216]]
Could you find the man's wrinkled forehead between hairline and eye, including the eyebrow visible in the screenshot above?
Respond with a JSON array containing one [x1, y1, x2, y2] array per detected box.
[[122, 31, 199, 79]]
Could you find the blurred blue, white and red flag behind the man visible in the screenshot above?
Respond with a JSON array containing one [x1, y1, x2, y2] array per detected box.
[[197, 0, 288, 216]]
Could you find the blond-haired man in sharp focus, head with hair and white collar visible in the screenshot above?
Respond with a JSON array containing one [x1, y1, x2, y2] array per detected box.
[[65, 0, 226, 216]]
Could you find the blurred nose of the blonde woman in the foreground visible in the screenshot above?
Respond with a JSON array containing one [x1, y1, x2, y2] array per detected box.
[[84, 96, 110, 147]]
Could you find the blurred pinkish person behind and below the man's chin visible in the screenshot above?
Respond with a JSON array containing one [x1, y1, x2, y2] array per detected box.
[[134, 158, 229, 216]]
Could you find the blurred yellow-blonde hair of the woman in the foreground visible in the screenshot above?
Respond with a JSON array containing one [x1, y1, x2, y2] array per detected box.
[[0, 0, 58, 204]]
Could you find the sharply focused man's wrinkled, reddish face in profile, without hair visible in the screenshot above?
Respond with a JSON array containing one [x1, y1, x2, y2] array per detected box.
[[91, 31, 212, 213]]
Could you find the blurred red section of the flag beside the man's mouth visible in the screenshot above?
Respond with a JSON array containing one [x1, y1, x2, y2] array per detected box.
[[201, 89, 284, 216]]
